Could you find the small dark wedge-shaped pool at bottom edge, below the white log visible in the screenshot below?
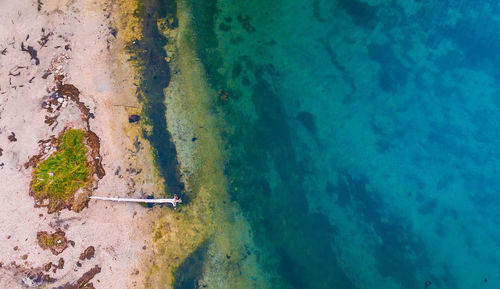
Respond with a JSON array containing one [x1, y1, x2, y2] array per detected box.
[[174, 242, 209, 289]]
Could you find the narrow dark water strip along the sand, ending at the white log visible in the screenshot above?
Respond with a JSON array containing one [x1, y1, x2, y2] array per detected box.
[[129, 0, 184, 199]]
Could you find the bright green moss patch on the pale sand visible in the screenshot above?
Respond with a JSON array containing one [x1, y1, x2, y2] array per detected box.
[[31, 129, 91, 213]]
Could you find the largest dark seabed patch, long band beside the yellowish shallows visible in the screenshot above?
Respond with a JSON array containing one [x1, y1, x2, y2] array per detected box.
[[222, 66, 355, 289]]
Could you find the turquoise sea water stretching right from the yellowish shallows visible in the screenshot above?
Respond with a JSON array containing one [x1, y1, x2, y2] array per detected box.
[[174, 0, 500, 289]]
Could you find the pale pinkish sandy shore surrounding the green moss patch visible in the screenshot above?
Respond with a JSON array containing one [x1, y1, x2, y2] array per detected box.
[[0, 0, 162, 288]]
